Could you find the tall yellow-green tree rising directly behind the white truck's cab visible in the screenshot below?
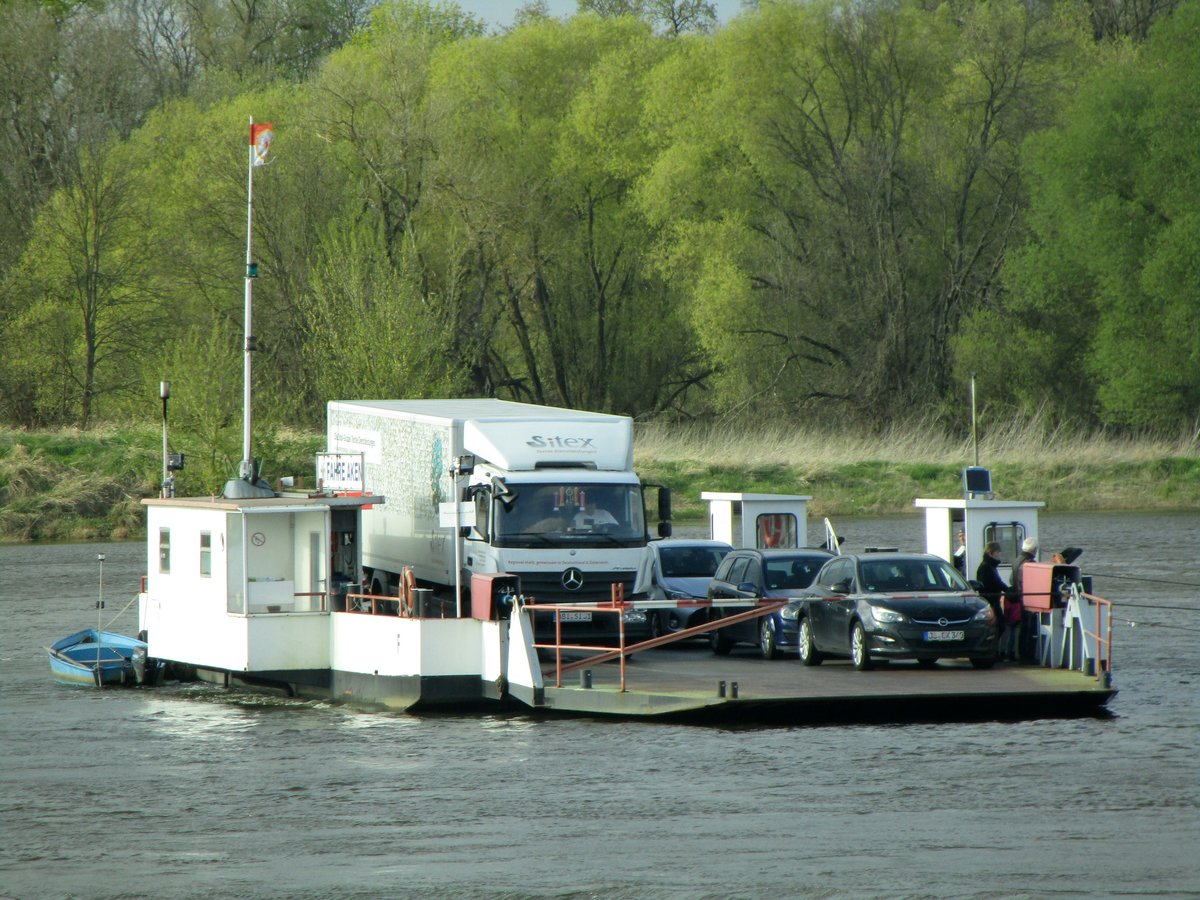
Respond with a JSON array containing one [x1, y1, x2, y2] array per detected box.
[[432, 16, 692, 412]]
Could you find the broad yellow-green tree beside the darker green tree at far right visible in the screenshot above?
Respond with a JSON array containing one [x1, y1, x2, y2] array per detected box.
[[641, 4, 1094, 422]]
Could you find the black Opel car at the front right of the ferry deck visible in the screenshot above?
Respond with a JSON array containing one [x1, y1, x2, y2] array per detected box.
[[790, 553, 998, 671]]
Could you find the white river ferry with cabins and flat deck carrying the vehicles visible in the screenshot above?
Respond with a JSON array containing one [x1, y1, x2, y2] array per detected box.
[[138, 457, 1116, 724]]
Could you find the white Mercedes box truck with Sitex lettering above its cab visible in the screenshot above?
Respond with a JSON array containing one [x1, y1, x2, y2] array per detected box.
[[328, 400, 671, 631]]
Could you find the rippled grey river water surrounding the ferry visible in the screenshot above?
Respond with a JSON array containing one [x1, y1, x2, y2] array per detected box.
[[0, 514, 1200, 898]]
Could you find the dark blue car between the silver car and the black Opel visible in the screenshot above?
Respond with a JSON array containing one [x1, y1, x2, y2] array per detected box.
[[708, 550, 833, 659]]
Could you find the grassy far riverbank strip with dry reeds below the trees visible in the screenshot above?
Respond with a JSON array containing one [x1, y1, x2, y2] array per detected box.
[[0, 426, 1200, 542]]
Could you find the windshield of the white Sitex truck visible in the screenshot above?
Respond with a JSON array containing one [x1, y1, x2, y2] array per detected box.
[[493, 482, 646, 547]]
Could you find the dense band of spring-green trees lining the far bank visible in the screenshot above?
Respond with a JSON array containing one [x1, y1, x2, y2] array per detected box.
[[0, 0, 1200, 480]]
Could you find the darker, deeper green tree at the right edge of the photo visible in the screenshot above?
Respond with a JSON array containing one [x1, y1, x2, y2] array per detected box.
[[972, 4, 1200, 428]]
